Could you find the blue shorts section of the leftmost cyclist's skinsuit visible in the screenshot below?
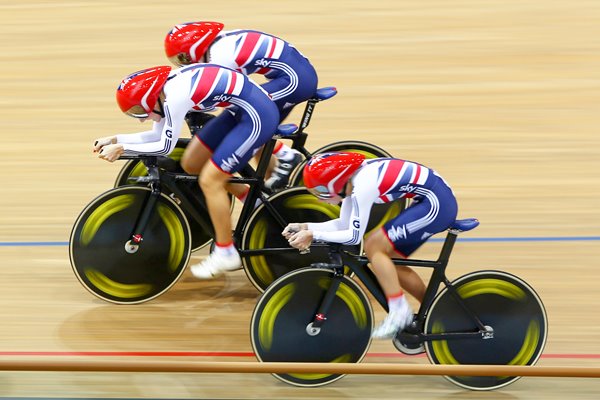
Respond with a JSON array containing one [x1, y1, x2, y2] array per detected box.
[[197, 85, 279, 174]]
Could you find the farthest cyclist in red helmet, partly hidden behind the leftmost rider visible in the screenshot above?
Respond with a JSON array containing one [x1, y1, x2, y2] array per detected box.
[[165, 21, 317, 191]]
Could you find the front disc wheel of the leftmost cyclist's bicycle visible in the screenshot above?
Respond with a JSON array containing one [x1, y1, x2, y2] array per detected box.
[[69, 186, 191, 304]]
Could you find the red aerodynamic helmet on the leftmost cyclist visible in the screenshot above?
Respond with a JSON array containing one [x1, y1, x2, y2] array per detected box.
[[117, 66, 171, 118]]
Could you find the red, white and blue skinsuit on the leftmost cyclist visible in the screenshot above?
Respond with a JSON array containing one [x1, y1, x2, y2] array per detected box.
[[117, 64, 279, 173]]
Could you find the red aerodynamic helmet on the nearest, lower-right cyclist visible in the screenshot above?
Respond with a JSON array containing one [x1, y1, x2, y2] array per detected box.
[[302, 153, 365, 200]]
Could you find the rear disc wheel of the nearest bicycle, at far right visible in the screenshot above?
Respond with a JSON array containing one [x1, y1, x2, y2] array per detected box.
[[425, 271, 548, 390]]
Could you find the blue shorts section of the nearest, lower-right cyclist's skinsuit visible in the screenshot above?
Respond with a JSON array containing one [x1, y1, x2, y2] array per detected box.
[[383, 180, 458, 257]]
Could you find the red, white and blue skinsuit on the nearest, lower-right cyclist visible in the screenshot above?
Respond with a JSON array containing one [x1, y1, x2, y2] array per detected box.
[[308, 158, 458, 257]]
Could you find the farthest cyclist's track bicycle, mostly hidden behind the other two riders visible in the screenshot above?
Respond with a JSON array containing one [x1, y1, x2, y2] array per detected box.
[[114, 87, 401, 251]]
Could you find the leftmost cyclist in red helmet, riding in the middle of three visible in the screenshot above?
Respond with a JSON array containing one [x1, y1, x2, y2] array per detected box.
[[94, 64, 279, 279]]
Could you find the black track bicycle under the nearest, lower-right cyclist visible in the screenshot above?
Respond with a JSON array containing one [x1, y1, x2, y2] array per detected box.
[[250, 219, 548, 390]]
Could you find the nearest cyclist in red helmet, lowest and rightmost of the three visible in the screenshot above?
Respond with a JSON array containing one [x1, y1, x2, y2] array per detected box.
[[283, 153, 458, 339]]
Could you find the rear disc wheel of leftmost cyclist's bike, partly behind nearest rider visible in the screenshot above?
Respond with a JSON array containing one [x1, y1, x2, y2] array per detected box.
[[241, 187, 362, 292]]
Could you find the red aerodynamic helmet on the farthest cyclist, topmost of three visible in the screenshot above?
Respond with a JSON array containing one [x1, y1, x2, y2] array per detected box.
[[165, 22, 224, 66]]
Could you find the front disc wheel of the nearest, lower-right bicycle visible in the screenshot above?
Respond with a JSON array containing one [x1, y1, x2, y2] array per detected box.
[[250, 268, 373, 387]]
